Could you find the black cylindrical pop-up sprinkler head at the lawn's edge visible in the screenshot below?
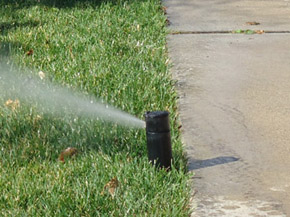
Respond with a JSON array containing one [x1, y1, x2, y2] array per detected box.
[[145, 111, 172, 169]]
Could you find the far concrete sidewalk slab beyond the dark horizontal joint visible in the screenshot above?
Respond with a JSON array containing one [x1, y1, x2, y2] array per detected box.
[[164, 0, 290, 31]]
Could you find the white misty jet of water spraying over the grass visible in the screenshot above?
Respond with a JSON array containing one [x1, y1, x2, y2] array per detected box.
[[0, 63, 145, 128]]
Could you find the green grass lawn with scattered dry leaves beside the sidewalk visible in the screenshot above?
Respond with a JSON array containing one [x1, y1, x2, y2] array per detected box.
[[0, 0, 190, 216]]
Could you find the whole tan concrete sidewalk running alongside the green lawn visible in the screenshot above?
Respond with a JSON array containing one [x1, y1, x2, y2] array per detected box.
[[164, 0, 290, 217]]
